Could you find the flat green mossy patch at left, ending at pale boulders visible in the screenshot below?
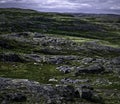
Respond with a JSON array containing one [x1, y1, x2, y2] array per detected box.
[[0, 63, 61, 83]]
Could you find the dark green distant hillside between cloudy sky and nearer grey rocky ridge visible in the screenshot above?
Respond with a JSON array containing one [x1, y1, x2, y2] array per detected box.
[[0, 8, 120, 45]]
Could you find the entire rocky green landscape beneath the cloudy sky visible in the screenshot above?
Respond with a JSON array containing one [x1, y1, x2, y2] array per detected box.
[[0, 9, 120, 104]]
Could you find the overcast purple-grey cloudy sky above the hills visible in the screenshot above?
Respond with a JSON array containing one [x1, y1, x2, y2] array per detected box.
[[0, 0, 120, 14]]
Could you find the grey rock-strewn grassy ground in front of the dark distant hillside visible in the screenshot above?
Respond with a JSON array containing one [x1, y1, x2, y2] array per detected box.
[[0, 32, 120, 104]]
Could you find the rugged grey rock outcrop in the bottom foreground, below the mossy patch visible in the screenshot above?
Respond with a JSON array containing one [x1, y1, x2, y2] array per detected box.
[[0, 78, 101, 104]]
